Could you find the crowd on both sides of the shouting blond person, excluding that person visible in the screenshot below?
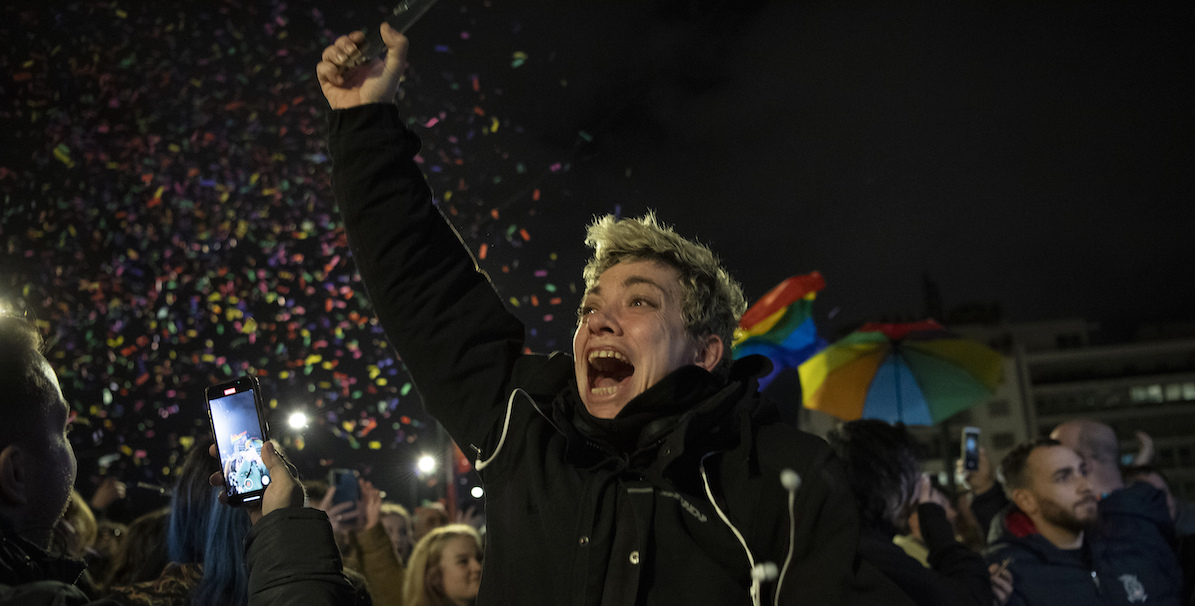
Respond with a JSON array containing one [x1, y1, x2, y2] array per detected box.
[[0, 303, 1195, 606]]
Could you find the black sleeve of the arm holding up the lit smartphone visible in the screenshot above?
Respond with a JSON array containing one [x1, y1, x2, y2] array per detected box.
[[245, 507, 357, 606]]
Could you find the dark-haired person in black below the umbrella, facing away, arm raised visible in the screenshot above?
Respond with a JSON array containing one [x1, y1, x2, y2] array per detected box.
[[829, 420, 992, 606]]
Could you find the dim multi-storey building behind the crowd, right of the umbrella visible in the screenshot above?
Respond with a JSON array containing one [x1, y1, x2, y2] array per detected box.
[[946, 320, 1195, 498]]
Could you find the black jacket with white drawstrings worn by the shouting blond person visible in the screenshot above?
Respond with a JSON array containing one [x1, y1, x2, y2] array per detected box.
[[330, 104, 905, 606]]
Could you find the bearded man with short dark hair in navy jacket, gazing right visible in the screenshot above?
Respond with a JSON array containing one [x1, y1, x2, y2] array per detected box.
[[986, 440, 1182, 606]]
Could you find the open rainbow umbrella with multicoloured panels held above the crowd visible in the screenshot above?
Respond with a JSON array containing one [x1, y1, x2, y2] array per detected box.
[[798, 320, 1004, 426]]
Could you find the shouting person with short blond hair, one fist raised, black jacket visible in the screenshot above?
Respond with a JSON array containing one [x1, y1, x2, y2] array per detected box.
[[317, 25, 907, 605]]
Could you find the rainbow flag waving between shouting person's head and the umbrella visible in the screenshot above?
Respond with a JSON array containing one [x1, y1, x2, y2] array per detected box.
[[731, 271, 826, 390]]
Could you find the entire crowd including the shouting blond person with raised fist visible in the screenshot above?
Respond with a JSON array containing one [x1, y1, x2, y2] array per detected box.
[[0, 16, 1193, 606]]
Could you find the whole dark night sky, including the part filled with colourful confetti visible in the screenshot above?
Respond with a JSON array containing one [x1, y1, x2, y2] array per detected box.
[[0, 0, 1195, 506]]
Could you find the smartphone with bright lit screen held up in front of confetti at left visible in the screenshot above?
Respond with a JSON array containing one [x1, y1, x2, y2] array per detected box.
[[208, 377, 270, 506]]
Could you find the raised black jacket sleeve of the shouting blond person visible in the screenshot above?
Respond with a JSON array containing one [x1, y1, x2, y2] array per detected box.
[[329, 104, 523, 466]]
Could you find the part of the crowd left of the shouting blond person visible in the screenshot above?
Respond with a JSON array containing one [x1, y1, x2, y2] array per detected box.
[[0, 316, 482, 606]]
